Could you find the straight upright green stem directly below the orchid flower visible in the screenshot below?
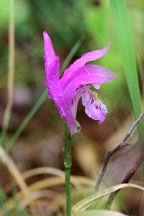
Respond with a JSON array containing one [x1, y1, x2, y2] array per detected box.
[[64, 125, 71, 216]]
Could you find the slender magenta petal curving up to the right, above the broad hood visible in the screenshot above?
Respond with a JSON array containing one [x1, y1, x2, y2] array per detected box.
[[63, 42, 111, 79]]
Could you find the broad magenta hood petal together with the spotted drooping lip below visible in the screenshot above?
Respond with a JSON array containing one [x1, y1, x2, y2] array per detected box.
[[61, 65, 116, 128]]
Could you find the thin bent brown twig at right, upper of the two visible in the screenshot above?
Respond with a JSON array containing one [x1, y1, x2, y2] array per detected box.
[[94, 110, 144, 193]]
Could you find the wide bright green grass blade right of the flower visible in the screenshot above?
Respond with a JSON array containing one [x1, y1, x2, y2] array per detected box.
[[110, 0, 144, 147]]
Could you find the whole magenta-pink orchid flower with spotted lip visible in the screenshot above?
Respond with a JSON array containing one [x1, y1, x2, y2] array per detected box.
[[43, 32, 116, 134]]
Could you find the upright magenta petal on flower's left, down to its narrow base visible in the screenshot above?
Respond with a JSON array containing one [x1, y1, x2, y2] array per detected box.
[[43, 32, 78, 134]]
